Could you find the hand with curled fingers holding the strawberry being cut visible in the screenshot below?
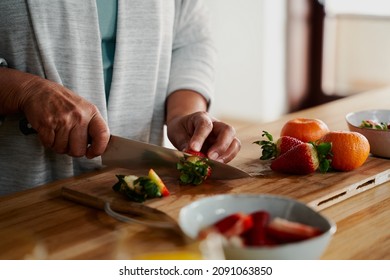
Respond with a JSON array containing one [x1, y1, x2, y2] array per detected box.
[[167, 112, 241, 163]]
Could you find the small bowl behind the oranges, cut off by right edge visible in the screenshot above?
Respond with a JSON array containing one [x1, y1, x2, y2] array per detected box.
[[345, 110, 390, 158]]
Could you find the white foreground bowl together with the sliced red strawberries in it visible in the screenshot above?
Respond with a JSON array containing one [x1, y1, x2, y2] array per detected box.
[[179, 194, 336, 260]]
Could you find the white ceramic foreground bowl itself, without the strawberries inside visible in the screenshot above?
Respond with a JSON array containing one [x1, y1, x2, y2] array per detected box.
[[179, 194, 336, 260]]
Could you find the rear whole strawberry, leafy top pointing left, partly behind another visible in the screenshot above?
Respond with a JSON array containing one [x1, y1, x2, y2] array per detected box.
[[253, 131, 303, 160]]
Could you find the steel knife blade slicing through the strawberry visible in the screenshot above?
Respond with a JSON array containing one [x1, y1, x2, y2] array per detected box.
[[102, 135, 251, 180]]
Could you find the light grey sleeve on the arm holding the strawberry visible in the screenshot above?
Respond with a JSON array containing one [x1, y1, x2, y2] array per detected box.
[[168, 0, 216, 107]]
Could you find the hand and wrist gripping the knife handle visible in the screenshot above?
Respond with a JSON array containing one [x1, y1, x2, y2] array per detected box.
[[0, 69, 110, 158]]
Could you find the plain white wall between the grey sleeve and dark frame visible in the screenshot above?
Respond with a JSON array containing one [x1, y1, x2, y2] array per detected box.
[[205, 0, 287, 122]]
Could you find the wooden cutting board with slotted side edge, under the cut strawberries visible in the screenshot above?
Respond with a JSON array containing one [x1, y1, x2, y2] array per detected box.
[[62, 157, 390, 219]]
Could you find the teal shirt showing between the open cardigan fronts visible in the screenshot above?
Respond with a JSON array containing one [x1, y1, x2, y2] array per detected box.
[[96, 0, 118, 100]]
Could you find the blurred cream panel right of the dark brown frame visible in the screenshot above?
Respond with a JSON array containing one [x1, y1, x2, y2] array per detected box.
[[322, 0, 390, 95]]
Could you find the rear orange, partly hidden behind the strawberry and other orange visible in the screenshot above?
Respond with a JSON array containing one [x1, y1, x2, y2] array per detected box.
[[280, 118, 329, 142]]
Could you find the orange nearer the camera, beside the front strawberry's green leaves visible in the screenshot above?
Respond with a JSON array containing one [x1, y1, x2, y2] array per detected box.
[[318, 131, 370, 171]]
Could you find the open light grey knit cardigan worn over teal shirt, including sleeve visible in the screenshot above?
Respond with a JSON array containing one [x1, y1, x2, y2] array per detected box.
[[0, 0, 215, 195]]
